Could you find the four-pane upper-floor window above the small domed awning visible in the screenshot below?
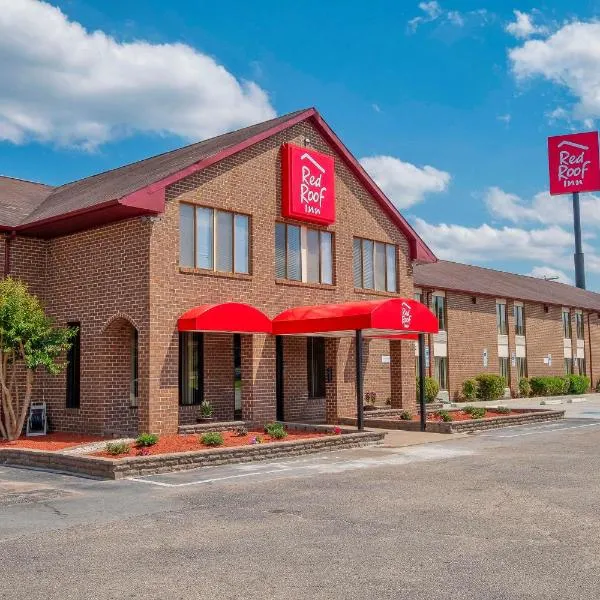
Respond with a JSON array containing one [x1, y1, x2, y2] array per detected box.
[[179, 203, 250, 273]]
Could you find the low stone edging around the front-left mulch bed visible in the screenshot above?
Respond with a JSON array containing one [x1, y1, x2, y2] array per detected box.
[[0, 431, 385, 479]]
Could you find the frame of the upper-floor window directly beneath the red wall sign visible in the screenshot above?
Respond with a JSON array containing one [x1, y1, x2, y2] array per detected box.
[[274, 221, 335, 286]]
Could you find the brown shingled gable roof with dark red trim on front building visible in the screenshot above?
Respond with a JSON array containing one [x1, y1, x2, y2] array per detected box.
[[0, 108, 436, 262]]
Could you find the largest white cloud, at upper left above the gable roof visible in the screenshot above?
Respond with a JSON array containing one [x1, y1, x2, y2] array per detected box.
[[0, 0, 275, 148]]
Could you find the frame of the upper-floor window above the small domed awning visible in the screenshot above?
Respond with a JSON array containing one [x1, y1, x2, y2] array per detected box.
[[179, 202, 252, 275]]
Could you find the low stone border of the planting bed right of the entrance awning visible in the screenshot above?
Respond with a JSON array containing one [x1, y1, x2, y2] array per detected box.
[[338, 408, 565, 433]]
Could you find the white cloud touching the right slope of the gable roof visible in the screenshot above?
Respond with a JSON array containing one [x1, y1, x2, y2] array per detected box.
[[360, 156, 451, 209]]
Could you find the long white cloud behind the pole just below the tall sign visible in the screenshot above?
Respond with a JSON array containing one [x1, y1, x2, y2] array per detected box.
[[483, 187, 600, 229]]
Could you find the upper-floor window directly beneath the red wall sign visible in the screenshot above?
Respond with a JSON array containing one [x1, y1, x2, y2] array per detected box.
[[275, 223, 333, 284]]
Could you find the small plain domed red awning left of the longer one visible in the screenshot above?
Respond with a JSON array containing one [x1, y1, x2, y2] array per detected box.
[[177, 302, 272, 333]]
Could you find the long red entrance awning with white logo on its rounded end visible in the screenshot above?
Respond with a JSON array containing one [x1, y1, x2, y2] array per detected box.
[[273, 298, 438, 339]]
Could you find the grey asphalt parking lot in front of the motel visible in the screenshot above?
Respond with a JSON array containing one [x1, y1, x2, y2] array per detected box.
[[0, 400, 600, 600]]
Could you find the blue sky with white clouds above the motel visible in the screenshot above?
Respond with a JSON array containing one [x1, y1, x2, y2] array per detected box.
[[0, 0, 600, 290]]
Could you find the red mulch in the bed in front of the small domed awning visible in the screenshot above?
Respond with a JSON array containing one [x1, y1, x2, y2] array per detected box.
[[92, 431, 331, 458]]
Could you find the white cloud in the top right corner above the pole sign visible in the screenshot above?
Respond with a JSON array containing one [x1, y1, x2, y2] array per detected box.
[[509, 21, 600, 126]]
